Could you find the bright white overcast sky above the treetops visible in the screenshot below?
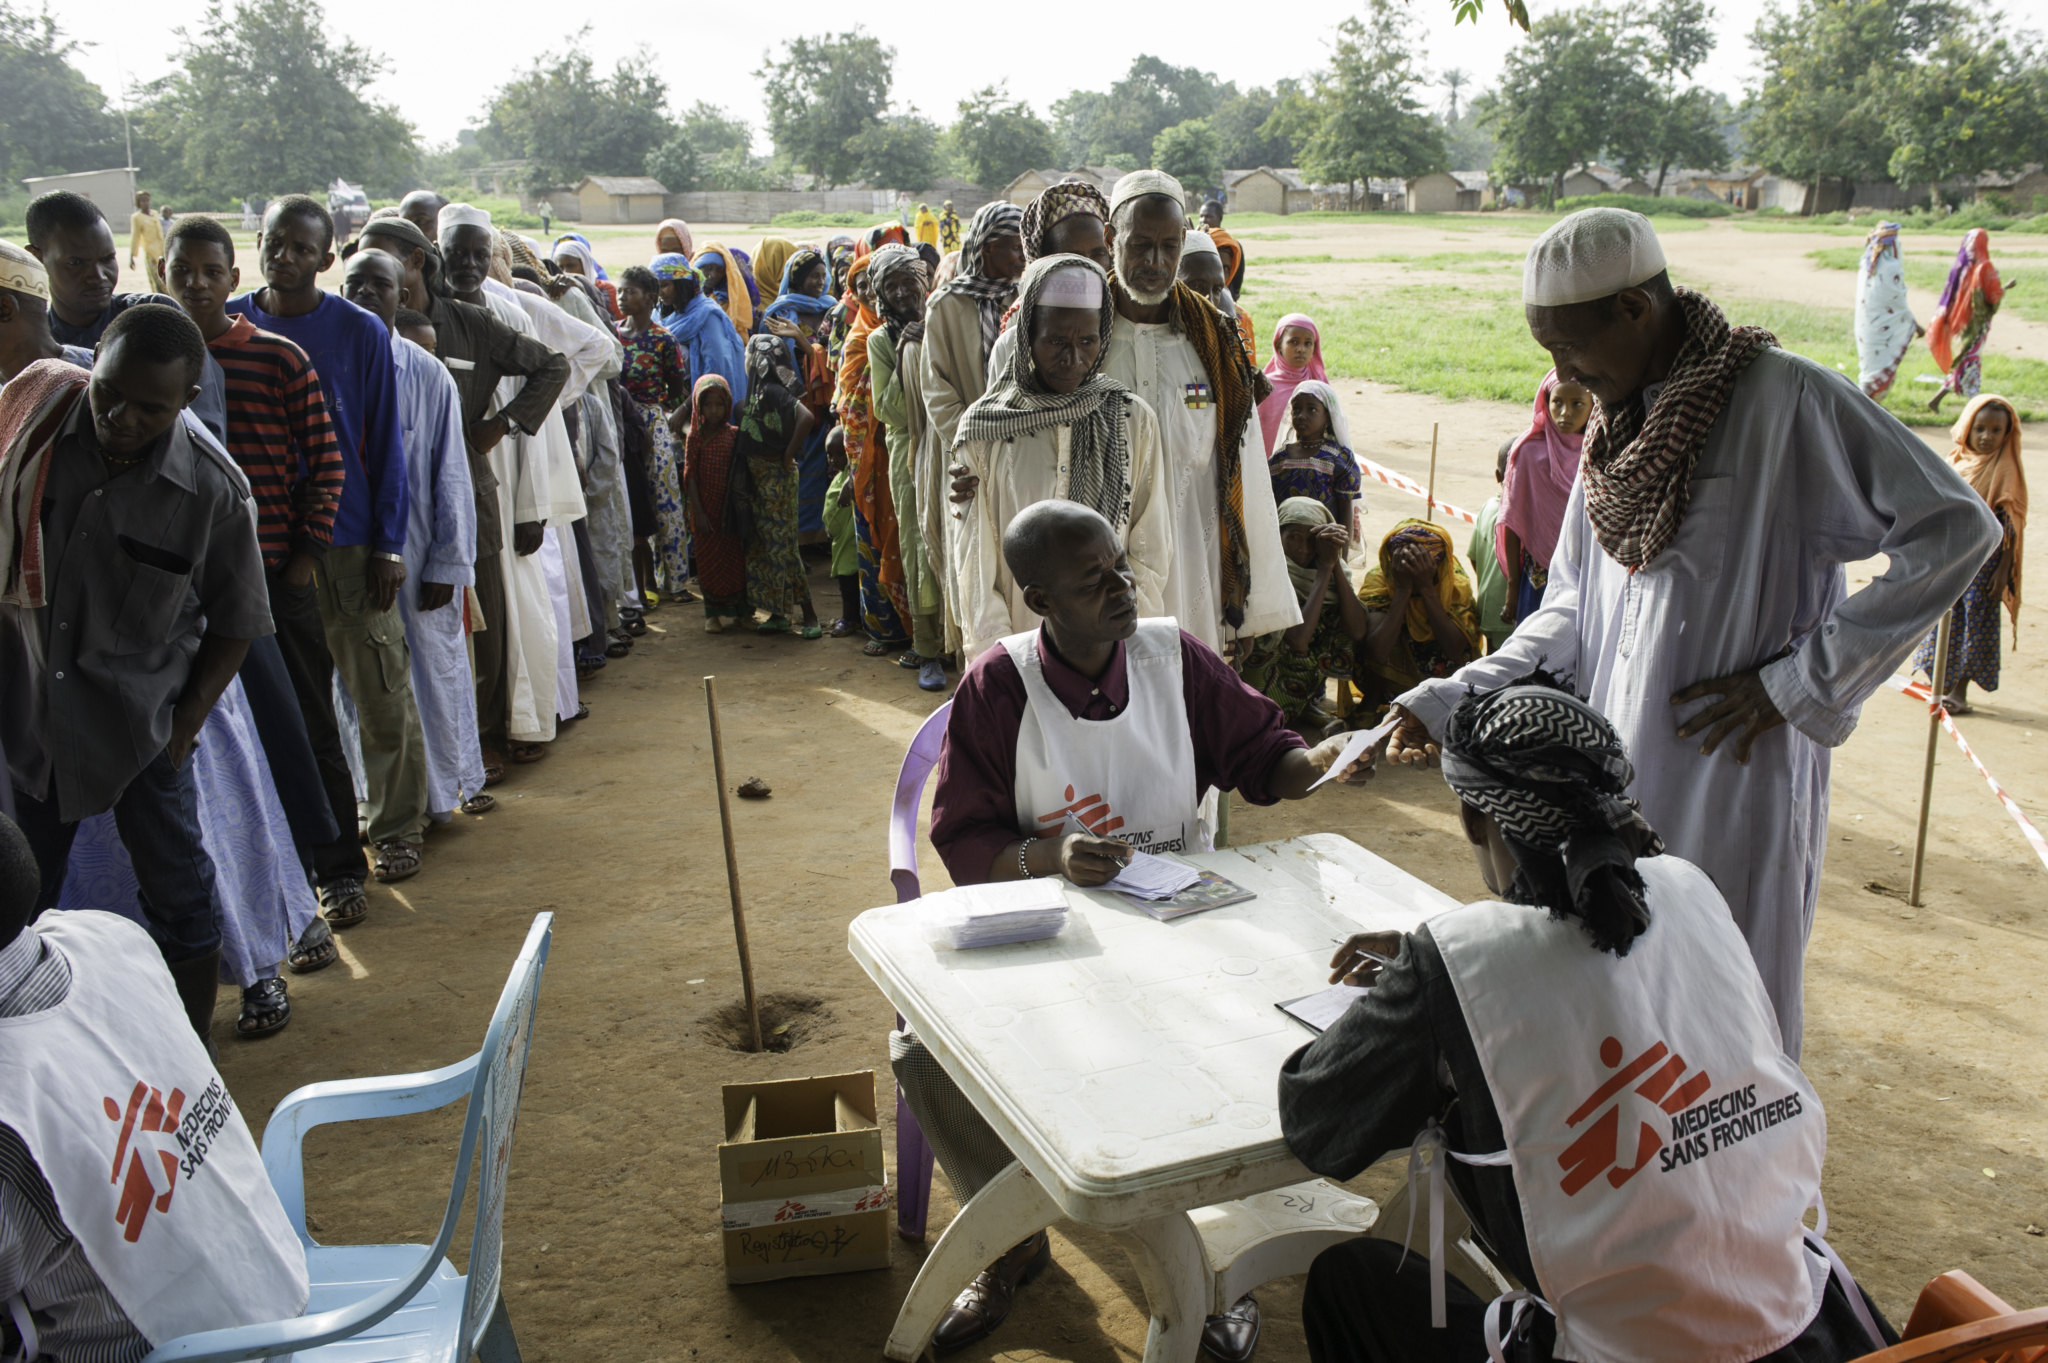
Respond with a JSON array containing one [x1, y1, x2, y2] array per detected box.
[[72, 0, 1785, 151]]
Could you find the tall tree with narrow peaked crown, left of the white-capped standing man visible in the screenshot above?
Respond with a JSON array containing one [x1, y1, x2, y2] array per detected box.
[[1266, 0, 1446, 199]]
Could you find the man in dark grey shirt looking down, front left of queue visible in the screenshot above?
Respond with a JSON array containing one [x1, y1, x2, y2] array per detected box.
[[0, 303, 270, 1036]]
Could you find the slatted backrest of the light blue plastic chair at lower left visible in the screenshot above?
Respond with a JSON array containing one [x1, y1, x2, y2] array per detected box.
[[462, 915, 553, 1357]]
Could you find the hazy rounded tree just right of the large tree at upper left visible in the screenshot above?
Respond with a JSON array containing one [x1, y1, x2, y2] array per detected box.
[[483, 29, 676, 186]]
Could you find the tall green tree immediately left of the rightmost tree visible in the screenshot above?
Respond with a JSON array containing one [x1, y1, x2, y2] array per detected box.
[[1747, 0, 1960, 190]]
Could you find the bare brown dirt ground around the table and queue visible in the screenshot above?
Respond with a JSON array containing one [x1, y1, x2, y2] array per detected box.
[[195, 223, 2048, 1363]]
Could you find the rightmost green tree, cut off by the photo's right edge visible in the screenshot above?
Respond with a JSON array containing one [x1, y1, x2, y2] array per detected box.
[[1884, 25, 2048, 205]]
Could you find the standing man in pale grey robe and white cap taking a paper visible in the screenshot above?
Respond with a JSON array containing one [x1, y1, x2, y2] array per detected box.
[[1389, 209, 1999, 1058]]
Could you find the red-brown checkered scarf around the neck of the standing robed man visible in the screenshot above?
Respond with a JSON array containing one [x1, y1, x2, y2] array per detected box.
[[1579, 289, 1778, 571]]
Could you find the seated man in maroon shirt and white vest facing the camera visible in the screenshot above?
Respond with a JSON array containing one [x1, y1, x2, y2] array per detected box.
[[917, 499, 1372, 1363]]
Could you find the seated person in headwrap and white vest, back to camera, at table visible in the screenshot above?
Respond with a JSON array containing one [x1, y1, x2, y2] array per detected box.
[[1280, 673, 1898, 1363]]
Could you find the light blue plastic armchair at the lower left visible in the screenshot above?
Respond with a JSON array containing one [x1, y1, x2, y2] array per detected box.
[[143, 913, 555, 1363]]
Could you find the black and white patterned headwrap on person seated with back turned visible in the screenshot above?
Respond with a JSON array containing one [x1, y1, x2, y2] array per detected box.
[[1442, 677, 1663, 950]]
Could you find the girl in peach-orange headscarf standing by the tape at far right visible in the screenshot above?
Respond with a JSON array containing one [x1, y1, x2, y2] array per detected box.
[[1913, 393, 2028, 714]]
